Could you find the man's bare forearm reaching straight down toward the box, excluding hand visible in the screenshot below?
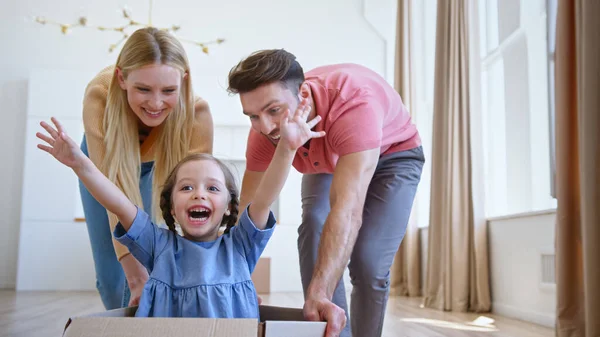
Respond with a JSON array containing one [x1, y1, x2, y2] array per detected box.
[[307, 148, 380, 301]]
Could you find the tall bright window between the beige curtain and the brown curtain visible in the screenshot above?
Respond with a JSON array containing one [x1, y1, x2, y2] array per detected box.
[[471, 0, 556, 217]]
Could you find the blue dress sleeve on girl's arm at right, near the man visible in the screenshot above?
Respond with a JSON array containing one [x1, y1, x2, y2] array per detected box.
[[230, 207, 276, 273]]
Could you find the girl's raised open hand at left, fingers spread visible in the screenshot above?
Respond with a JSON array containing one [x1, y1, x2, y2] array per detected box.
[[35, 117, 87, 169]]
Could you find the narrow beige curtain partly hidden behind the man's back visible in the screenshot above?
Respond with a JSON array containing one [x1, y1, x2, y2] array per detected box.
[[390, 0, 421, 296]]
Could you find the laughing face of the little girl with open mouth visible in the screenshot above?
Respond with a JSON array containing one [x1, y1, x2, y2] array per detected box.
[[171, 160, 230, 241]]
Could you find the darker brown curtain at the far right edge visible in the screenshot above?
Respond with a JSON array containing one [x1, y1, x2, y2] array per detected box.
[[555, 0, 600, 337]]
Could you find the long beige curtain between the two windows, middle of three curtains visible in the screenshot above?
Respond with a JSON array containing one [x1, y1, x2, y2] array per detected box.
[[424, 0, 491, 312]]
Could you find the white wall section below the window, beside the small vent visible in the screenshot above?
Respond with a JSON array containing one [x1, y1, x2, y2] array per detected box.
[[489, 211, 556, 327]]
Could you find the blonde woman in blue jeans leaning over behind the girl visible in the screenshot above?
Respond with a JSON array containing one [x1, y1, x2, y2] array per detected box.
[[79, 27, 213, 310]]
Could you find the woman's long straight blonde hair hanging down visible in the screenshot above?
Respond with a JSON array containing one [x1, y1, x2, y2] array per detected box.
[[101, 27, 194, 221]]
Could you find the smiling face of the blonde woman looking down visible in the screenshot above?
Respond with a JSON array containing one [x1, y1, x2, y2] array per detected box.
[[117, 64, 183, 128]]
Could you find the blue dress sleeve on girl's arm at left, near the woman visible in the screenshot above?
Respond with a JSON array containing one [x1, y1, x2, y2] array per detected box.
[[113, 208, 172, 271]]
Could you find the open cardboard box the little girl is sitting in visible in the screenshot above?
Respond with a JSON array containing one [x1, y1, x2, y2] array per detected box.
[[63, 305, 327, 337]]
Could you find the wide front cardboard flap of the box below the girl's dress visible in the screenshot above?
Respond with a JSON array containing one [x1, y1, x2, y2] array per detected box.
[[64, 316, 258, 337]]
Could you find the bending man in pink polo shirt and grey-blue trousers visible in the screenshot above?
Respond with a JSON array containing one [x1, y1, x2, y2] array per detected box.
[[228, 49, 424, 337]]
